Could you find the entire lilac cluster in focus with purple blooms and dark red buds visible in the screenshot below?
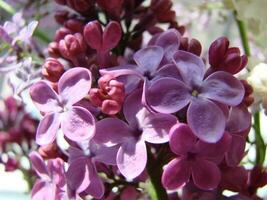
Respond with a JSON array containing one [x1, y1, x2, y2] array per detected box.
[[2, 0, 267, 200]]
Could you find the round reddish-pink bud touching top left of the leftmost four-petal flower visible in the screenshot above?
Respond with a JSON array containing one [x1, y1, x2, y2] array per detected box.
[[42, 58, 65, 82]]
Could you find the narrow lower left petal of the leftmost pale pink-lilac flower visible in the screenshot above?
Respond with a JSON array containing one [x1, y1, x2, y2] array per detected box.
[[36, 113, 60, 145]]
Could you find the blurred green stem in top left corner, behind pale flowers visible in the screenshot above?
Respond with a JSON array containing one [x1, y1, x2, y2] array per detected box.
[[0, 0, 51, 43]]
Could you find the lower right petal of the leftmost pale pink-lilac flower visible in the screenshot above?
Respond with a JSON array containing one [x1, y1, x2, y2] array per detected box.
[[61, 106, 95, 141]]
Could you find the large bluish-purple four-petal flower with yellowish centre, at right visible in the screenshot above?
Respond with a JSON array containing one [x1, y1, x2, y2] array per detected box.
[[145, 51, 244, 143]]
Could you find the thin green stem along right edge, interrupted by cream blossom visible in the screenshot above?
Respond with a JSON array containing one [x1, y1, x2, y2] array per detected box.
[[234, 11, 266, 165]]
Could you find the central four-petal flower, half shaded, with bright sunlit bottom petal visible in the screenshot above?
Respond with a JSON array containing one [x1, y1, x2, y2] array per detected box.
[[94, 90, 177, 179]]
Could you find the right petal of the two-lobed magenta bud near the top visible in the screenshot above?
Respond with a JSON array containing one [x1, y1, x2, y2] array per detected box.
[[102, 21, 122, 51]]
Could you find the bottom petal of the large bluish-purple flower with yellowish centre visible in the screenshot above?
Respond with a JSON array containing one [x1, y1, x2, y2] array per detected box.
[[187, 98, 226, 143]]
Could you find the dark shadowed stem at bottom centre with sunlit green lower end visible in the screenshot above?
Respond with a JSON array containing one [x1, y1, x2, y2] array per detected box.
[[147, 146, 168, 200]]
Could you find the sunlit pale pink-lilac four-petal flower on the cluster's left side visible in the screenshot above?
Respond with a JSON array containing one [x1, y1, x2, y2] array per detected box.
[[30, 67, 95, 145]]
